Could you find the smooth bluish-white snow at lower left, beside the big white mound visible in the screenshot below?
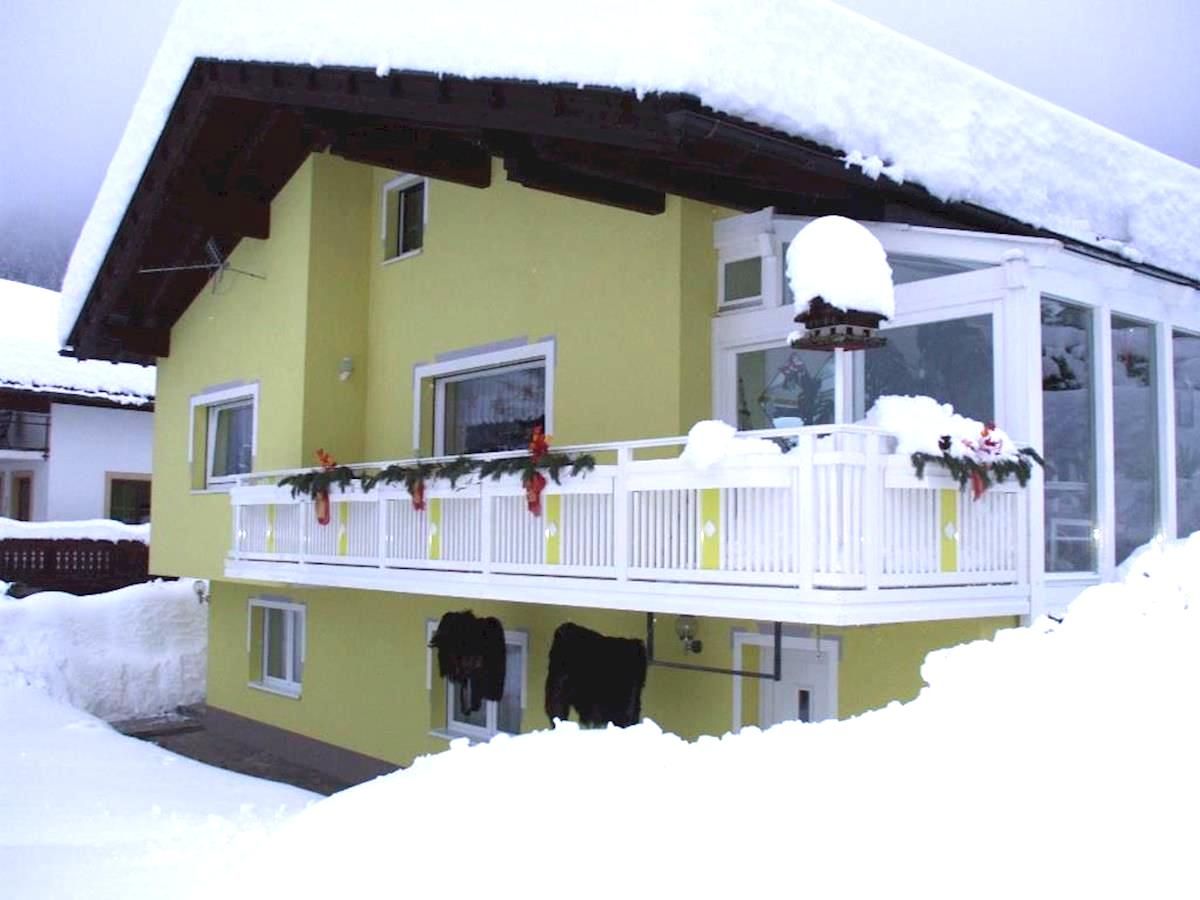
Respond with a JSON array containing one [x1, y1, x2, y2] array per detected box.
[[0, 683, 316, 900]]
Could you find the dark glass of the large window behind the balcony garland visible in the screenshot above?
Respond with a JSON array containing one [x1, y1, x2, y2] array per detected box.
[[443, 364, 546, 454]]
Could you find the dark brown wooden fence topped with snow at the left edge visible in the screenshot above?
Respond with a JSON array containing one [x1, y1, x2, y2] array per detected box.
[[0, 539, 150, 594]]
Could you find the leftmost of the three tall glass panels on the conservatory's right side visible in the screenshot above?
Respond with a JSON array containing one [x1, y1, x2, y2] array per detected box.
[[1042, 299, 1096, 572]]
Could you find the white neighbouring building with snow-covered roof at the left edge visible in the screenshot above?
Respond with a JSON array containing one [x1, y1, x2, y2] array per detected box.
[[0, 281, 155, 524]]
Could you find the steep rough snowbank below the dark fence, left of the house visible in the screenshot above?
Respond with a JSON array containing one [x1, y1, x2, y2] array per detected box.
[[0, 580, 208, 720]]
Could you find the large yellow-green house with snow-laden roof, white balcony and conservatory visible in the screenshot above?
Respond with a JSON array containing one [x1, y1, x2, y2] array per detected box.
[[61, 0, 1200, 776]]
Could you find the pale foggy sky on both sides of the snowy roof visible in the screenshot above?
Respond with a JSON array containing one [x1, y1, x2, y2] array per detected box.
[[0, 0, 1200, 288]]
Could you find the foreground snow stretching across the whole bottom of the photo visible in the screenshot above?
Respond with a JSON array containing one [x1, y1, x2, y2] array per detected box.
[[0, 542, 1200, 900]]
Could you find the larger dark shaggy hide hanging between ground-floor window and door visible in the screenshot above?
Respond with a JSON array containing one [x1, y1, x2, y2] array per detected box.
[[546, 622, 646, 727]]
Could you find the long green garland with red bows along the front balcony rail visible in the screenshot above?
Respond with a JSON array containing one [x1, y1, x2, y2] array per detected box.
[[278, 427, 596, 516]]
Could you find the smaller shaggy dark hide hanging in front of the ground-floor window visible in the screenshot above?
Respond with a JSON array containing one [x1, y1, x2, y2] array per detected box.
[[430, 610, 506, 713]]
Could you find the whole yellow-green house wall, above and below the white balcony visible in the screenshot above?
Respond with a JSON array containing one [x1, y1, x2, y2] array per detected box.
[[151, 155, 1013, 764]]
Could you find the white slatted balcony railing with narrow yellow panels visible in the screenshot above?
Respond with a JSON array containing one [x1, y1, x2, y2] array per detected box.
[[224, 426, 1030, 625]]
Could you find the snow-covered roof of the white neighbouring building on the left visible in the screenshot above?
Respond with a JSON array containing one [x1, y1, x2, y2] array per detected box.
[[0, 280, 155, 406]]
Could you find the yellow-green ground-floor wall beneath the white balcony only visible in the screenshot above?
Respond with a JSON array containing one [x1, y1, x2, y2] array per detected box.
[[208, 582, 1014, 764]]
